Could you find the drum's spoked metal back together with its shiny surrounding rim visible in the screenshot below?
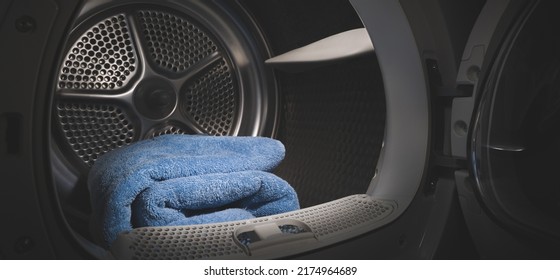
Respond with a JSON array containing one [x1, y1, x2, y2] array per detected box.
[[51, 1, 278, 237]]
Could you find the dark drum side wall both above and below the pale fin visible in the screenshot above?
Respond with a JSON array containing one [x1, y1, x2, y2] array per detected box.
[[244, 0, 385, 207]]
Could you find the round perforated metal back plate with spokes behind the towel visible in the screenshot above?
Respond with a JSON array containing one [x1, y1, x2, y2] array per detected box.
[[55, 7, 243, 166]]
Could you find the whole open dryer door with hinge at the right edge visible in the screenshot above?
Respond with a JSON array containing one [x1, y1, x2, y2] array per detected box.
[[450, 1, 560, 259]]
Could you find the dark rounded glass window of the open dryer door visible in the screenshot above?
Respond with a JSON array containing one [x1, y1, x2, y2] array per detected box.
[[472, 1, 560, 241]]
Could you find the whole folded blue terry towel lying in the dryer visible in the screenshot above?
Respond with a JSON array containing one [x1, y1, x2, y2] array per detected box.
[[88, 135, 299, 247]]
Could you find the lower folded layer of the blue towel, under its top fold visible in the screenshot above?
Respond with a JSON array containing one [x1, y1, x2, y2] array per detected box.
[[132, 171, 298, 226]]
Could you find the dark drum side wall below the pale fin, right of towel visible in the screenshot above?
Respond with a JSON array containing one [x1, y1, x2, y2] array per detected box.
[[276, 57, 385, 206]]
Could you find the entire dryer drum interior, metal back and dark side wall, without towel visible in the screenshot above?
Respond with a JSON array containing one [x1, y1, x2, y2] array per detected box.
[[52, 0, 386, 256]]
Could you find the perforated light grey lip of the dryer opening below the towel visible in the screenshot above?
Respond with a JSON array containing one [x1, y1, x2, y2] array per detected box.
[[111, 195, 397, 259]]
